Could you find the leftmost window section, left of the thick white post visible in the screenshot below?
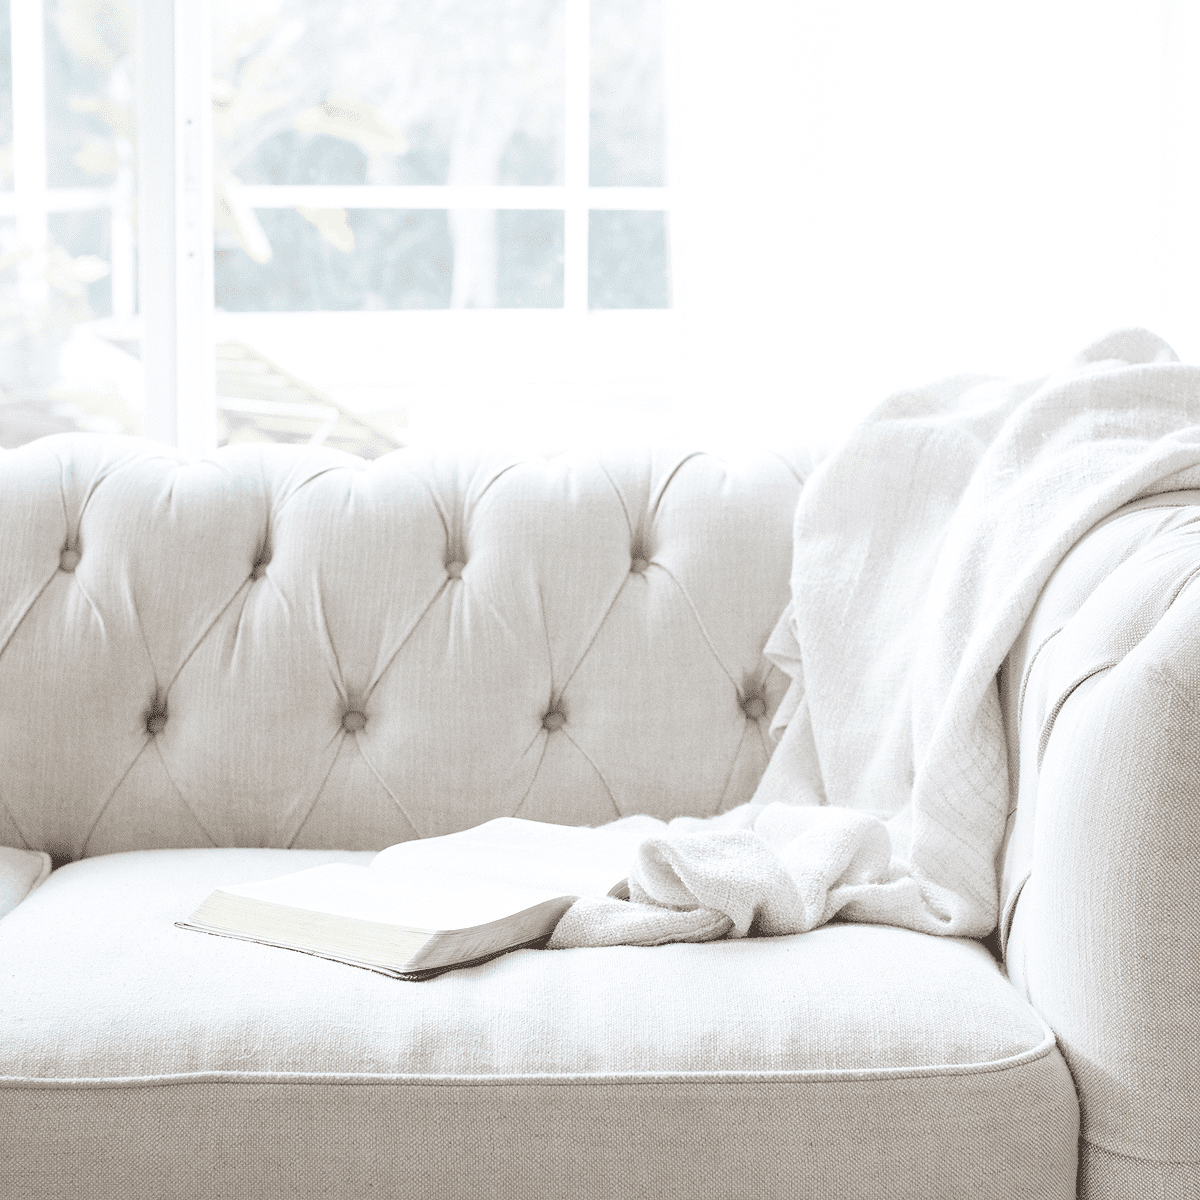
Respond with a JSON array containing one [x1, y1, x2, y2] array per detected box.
[[0, 0, 142, 445]]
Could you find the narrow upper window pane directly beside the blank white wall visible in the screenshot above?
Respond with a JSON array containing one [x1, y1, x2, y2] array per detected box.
[[590, 0, 665, 186]]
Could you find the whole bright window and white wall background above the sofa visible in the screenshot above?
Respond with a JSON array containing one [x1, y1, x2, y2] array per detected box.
[[0, 0, 1200, 456]]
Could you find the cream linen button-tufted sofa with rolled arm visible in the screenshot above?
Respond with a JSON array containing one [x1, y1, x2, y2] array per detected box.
[[0, 434, 1200, 1200]]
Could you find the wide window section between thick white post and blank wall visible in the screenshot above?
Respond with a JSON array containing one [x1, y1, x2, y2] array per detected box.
[[214, 0, 670, 454]]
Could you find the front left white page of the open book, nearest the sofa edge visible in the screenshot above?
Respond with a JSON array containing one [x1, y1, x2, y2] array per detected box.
[[218, 863, 600, 931]]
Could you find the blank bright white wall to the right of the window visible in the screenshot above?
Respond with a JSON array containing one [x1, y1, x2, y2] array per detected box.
[[667, 0, 1200, 446]]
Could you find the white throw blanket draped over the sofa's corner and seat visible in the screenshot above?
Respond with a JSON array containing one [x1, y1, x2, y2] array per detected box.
[[548, 330, 1200, 949]]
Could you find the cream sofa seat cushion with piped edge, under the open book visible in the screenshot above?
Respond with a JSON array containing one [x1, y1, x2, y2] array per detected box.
[[0, 850, 1078, 1196]]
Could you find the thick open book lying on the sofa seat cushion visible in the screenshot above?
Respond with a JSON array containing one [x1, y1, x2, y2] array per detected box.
[[175, 817, 646, 979]]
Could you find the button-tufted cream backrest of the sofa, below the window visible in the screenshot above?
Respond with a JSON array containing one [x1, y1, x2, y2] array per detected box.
[[0, 434, 811, 860]]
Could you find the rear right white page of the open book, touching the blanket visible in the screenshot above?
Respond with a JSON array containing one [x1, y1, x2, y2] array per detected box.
[[368, 817, 646, 902]]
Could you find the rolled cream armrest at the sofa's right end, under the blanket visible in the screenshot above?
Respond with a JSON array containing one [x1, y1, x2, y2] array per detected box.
[[1000, 493, 1200, 1196]]
